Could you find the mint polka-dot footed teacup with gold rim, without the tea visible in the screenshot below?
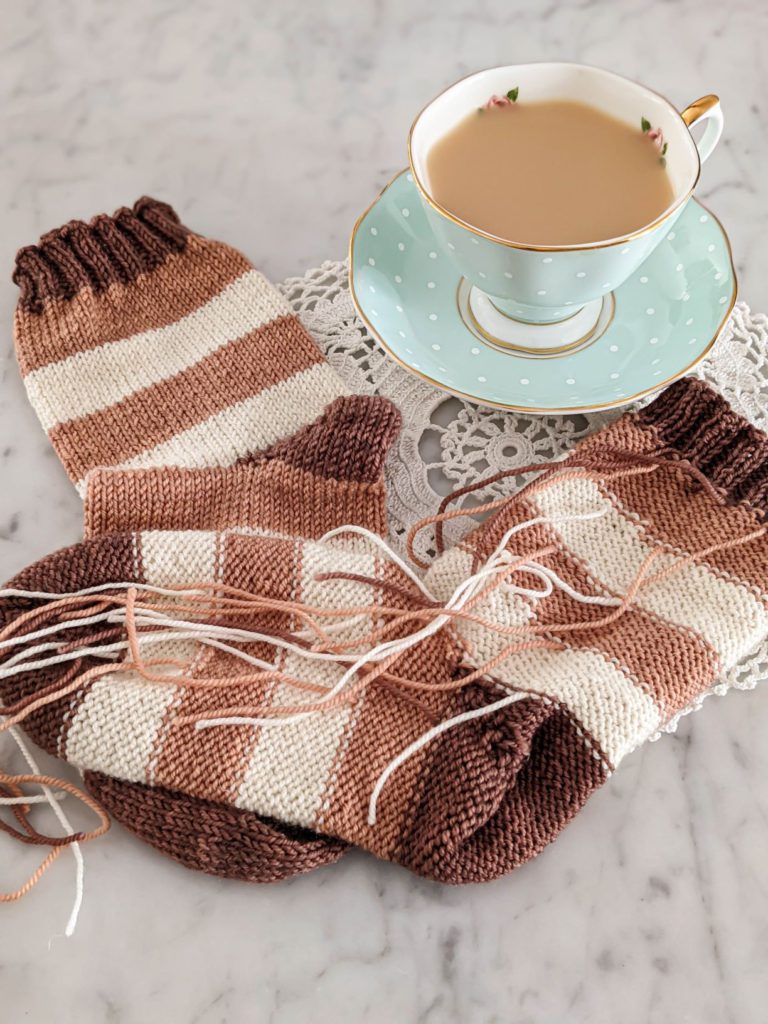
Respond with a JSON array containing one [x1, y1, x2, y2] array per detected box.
[[409, 63, 723, 350]]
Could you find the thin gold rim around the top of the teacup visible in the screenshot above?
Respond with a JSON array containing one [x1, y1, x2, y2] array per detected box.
[[408, 60, 717, 253]]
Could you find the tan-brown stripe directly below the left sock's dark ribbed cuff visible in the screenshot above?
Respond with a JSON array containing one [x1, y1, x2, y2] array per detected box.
[[14, 236, 253, 375]]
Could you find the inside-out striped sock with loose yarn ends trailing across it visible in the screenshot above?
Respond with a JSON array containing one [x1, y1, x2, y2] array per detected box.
[[0, 372, 768, 883]]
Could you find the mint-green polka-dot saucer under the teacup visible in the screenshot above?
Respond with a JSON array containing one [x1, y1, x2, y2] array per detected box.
[[349, 171, 736, 413]]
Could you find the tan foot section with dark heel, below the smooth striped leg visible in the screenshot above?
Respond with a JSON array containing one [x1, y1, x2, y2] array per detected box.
[[85, 395, 400, 538]]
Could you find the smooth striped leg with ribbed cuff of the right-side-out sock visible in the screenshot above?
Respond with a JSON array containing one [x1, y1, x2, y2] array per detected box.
[[13, 198, 347, 494]]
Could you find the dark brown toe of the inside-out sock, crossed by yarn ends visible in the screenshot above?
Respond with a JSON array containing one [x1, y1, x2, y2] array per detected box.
[[0, 535, 142, 755]]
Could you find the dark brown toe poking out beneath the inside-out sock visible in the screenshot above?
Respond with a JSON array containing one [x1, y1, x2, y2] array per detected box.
[[84, 772, 348, 882]]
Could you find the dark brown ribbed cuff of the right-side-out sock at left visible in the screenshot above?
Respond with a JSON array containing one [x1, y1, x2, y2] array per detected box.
[[13, 196, 188, 313]]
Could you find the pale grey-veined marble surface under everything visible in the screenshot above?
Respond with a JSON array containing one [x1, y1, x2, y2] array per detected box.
[[0, 0, 768, 1024]]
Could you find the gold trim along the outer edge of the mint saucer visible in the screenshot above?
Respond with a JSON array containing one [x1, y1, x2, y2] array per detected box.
[[348, 168, 738, 416]]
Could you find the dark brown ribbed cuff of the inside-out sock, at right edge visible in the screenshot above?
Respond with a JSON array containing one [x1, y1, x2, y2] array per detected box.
[[635, 377, 768, 513]]
